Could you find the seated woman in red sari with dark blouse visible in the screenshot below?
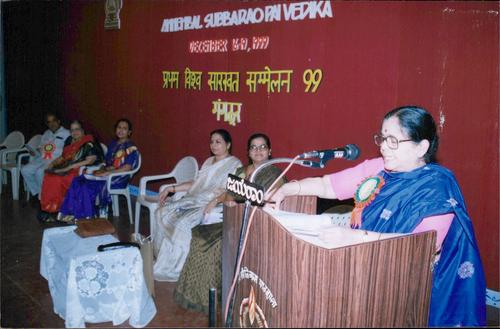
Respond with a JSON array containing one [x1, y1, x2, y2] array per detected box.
[[38, 120, 103, 221]]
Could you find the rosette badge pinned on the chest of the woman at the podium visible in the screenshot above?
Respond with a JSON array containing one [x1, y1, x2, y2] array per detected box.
[[351, 176, 385, 228]]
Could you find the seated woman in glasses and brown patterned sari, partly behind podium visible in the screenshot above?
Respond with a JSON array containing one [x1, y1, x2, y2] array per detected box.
[[174, 133, 285, 313]]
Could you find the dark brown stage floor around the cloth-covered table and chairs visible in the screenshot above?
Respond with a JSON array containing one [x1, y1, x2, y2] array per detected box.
[[0, 181, 499, 328]]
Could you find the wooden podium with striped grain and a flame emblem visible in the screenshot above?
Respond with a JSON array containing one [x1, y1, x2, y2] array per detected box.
[[222, 197, 436, 327]]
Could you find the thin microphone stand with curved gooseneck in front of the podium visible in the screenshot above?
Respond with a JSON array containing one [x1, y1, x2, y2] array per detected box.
[[226, 158, 318, 328]]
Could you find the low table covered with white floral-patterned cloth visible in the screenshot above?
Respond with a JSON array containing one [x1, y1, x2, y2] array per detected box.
[[40, 225, 156, 328]]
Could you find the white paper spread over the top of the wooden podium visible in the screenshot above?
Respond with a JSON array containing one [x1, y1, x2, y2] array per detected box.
[[264, 209, 404, 249]]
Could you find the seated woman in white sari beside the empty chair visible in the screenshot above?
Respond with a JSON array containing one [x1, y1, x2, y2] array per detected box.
[[152, 129, 241, 282]]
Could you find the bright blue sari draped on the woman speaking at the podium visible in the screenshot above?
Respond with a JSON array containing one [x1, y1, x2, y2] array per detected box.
[[361, 164, 486, 327]]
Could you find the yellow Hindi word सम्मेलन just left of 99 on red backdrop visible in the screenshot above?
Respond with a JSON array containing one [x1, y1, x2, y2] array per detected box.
[[246, 66, 293, 93]]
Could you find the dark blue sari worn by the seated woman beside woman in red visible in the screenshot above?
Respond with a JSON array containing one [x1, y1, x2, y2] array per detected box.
[[60, 140, 139, 219]]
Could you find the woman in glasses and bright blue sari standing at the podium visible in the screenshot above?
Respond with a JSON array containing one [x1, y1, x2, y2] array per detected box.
[[271, 106, 486, 327]]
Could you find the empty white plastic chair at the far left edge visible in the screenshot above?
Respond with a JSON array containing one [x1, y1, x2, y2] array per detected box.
[[0, 131, 26, 200]]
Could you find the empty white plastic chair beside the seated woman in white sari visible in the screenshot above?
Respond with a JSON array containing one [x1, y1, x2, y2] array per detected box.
[[135, 156, 198, 234]]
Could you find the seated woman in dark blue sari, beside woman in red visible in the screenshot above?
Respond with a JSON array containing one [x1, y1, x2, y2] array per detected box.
[[58, 118, 139, 222]]
